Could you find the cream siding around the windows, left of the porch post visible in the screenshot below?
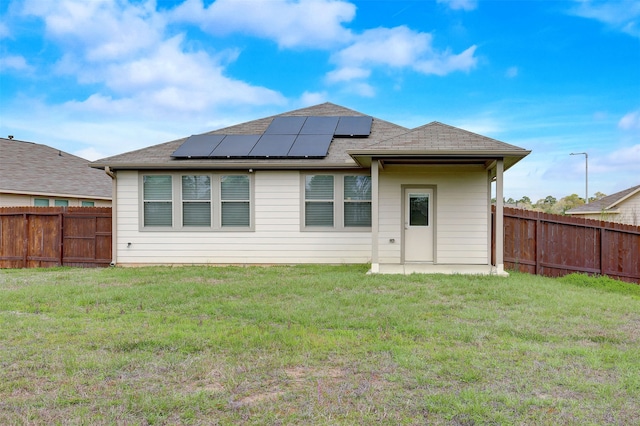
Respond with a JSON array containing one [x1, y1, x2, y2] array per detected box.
[[117, 171, 371, 264]]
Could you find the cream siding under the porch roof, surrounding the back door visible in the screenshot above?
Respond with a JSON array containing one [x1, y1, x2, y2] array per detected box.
[[379, 166, 489, 264]]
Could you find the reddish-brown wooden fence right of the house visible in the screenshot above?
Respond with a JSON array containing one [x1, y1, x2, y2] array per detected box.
[[494, 208, 640, 284]]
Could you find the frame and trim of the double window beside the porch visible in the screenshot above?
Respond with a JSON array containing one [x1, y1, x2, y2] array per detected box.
[[300, 170, 374, 232]]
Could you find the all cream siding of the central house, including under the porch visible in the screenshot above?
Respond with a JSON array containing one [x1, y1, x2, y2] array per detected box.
[[116, 166, 488, 265]]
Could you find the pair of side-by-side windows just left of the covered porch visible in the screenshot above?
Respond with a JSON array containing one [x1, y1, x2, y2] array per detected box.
[[303, 174, 371, 230]]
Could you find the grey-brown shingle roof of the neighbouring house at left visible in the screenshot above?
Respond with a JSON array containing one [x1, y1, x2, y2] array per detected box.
[[0, 138, 112, 200]]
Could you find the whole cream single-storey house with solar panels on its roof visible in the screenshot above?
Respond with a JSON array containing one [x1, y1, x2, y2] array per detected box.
[[92, 103, 529, 274]]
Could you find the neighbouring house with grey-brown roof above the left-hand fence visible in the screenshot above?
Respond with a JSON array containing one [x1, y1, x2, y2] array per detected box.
[[0, 138, 112, 207]]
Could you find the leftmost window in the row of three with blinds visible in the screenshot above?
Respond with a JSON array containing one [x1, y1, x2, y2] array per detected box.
[[143, 175, 173, 226]]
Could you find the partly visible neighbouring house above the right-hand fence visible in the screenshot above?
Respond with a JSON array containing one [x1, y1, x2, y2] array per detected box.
[[565, 185, 640, 226]]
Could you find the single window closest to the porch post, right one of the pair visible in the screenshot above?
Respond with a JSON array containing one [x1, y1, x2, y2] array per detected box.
[[344, 176, 371, 227]]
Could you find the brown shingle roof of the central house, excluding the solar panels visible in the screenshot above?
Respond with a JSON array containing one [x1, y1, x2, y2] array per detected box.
[[91, 103, 530, 170]]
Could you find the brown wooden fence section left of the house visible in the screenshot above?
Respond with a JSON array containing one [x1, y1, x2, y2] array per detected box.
[[0, 207, 111, 268]]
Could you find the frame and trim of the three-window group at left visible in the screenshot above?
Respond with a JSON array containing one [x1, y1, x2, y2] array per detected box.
[[138, 170, 255, 232]]
